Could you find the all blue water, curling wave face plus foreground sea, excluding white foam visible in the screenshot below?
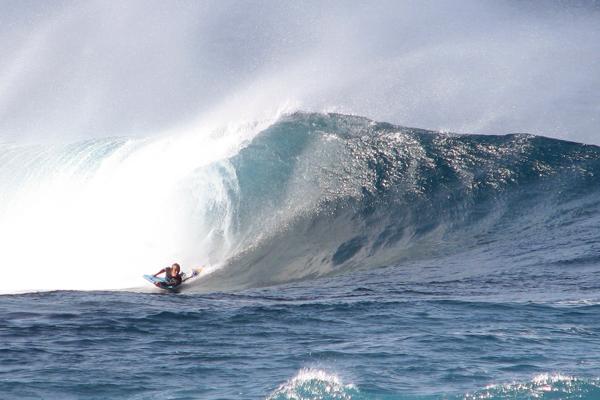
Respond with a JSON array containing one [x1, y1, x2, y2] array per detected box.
[[0, 114, 600, 399]]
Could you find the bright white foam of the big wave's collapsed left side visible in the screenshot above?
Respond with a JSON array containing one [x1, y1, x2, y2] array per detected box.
[[0, 109, 284, 293]]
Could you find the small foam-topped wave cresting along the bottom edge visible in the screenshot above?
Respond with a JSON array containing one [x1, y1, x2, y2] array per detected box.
[[267, 368, 600, 400]]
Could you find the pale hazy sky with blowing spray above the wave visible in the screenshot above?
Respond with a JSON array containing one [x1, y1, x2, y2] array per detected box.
[[0, 0, 600, 145]]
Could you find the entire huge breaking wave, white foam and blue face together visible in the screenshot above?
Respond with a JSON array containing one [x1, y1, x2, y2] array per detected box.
[[0, 113, 600, 292]]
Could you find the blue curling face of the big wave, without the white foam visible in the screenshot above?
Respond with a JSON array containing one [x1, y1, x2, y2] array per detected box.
[[196, 113, 600, 290]]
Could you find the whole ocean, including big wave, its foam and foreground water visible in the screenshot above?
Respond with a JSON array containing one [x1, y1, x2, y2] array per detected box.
[[0, 113, 600, 400]]
